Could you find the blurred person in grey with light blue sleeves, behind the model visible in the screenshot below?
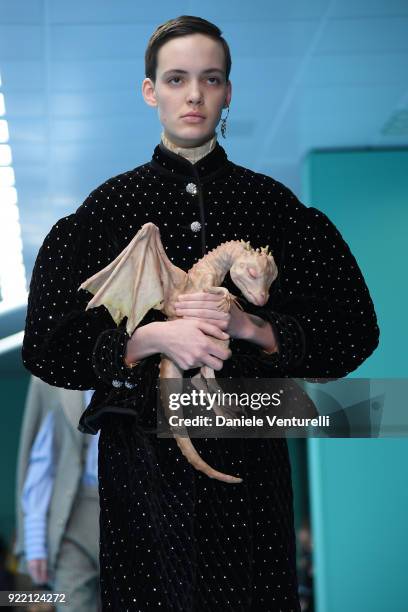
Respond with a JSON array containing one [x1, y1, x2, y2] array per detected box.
[[15, 377, 100, 612]]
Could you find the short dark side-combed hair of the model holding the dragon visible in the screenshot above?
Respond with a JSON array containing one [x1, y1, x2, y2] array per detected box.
[[145, 15, 232, 82]]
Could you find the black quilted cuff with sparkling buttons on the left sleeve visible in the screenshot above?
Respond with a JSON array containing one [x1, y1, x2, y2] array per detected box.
[[92, 327, 144, 389]]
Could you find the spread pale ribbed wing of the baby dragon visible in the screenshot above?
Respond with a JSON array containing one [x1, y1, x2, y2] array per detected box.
[[78, 223, 187, 335]]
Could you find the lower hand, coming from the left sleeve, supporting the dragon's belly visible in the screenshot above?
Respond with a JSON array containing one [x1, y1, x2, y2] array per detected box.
[[156, 318, 231, 370]]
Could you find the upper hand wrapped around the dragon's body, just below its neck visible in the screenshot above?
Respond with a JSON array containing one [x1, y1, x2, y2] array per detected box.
[[174, 292, 252, 339]]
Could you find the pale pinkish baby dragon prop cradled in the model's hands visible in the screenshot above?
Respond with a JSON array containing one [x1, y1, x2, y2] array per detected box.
[[79, 223, 278, 483]]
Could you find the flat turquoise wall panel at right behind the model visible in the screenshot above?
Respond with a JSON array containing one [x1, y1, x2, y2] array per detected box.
[[302, 149, 408, 612]]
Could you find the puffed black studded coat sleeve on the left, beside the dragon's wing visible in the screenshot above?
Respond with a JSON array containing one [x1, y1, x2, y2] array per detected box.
[[22, 211, 147, 389]]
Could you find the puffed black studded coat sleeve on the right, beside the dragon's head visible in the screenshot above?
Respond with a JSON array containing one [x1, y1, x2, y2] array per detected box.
[[242, 198, 379, 379]]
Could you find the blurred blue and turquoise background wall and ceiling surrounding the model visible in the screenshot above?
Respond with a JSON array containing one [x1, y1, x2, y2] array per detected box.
[[0, 0, 408, 612]]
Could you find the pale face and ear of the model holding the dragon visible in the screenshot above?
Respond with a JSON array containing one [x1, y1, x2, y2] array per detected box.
[[142, 34, 231, 147]]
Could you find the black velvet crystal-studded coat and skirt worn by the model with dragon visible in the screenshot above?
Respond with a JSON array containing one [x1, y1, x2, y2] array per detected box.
[[23, 144, 379, 612]]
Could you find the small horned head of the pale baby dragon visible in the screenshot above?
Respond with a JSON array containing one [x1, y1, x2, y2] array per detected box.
[[230, 240, 278, 306]]
